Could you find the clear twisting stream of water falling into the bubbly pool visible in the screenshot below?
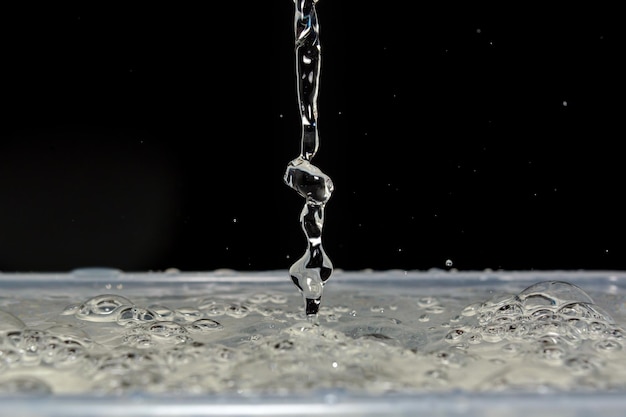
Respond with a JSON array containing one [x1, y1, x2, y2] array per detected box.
[[284, 0, 333, 320]]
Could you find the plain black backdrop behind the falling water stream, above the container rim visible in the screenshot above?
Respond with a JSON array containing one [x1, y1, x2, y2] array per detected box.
[[0, 0, 626, 272]]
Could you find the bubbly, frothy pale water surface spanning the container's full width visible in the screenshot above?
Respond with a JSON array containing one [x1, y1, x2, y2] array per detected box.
[[0, 281, 626, 395]]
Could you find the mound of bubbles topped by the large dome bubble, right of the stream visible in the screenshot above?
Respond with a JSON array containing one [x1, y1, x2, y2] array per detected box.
[[435, 281, 625, 390]]
